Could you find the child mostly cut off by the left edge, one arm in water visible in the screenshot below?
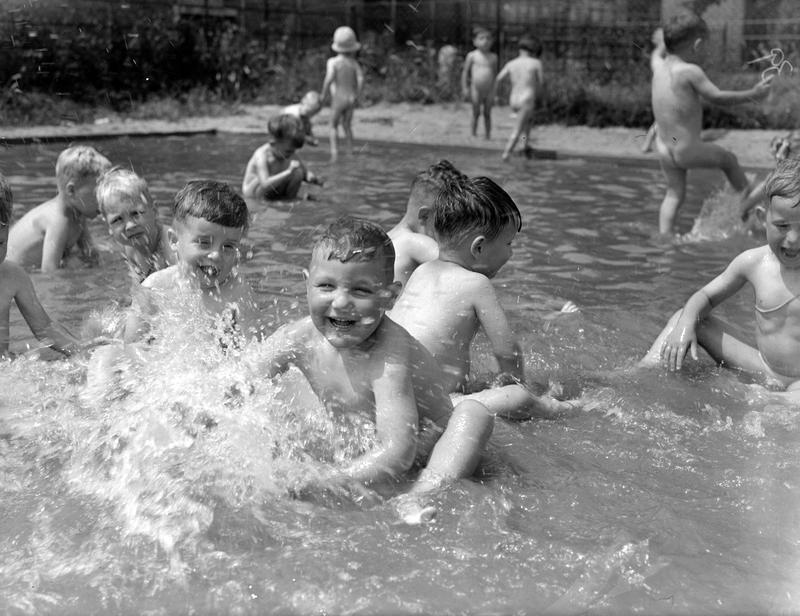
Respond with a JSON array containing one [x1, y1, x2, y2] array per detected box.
[[0, 174, 80, 357]]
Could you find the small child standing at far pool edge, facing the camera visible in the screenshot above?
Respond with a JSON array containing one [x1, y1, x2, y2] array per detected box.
[[461, 28, 497, 139]]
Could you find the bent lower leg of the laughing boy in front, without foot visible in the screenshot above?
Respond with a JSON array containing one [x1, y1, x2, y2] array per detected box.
[[409, 400, 494, 494]]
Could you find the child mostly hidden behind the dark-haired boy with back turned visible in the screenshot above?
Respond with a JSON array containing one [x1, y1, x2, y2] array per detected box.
[[389, 159, 466, 285]]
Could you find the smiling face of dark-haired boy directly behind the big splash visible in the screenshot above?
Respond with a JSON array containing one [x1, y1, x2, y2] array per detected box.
[[169, 216, 244, 290]]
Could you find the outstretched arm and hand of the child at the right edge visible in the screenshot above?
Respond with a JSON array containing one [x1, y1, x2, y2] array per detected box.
[[661, 250, 760, 370]]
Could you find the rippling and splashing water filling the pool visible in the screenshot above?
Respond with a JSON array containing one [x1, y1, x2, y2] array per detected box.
[[0, 135, 800, 614]]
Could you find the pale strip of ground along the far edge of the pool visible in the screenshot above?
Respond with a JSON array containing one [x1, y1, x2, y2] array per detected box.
[[0, 103, 785, 169]]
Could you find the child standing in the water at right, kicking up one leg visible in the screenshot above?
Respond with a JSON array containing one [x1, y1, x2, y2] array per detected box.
[[652, 12, 770, 233]]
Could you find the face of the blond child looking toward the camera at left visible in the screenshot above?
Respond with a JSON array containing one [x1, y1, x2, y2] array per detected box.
[[103, 192, 158, 252]]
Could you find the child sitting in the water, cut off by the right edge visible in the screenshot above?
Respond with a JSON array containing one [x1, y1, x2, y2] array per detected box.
[[642, 159, 800, 390]]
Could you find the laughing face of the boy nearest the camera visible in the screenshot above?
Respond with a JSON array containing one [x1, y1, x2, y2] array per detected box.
[[307, 254, 396, 349]]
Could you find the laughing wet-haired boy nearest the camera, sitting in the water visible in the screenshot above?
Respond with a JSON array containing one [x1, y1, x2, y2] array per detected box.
[[252, 217, 493, 522]]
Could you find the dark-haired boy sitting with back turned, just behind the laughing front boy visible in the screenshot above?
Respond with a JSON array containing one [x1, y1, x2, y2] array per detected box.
[[389, 177, 573, 418]]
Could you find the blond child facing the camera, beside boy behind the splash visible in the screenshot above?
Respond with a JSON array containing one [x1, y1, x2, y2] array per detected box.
[[95, 167, 175, 284]]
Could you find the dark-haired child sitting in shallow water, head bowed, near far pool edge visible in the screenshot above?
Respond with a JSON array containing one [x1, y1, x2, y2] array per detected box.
[[242, 114, 322, 200]]
